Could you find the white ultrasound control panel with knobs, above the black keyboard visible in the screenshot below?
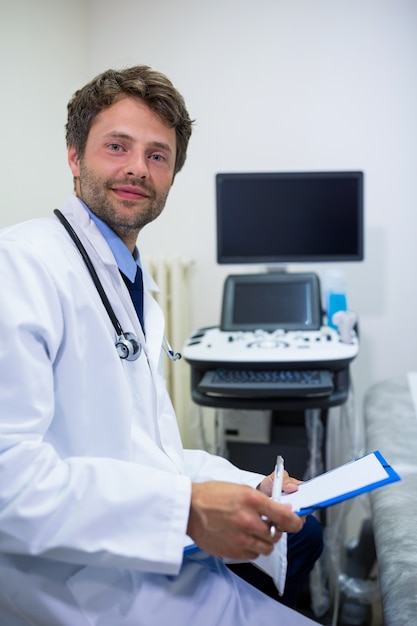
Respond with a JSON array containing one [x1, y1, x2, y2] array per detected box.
[[183, 326, 359, 370]]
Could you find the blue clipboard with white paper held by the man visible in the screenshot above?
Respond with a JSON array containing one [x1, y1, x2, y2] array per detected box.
[[280, 450, 401, 515]]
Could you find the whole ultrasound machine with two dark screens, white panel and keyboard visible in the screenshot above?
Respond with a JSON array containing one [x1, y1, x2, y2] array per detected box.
[[183, 171, 364, 475]]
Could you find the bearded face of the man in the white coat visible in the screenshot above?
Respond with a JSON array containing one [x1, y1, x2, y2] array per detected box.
[[68, 97, 176, 250]]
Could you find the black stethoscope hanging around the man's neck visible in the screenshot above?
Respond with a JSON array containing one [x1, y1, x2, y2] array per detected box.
[[54, 209, 181, 361]]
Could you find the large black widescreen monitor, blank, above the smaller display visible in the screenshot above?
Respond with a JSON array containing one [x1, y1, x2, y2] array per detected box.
[[216, 172, 363, 264]]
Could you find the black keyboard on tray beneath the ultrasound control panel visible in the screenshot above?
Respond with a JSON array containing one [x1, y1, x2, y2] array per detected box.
[[197, 368, 333, 398]]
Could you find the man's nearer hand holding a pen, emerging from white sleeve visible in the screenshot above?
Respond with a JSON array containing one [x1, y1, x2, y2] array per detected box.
[[187, 479, 303, 560]]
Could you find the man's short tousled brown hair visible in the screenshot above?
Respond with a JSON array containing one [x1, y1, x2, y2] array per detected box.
[[66, 65, 193, 175]]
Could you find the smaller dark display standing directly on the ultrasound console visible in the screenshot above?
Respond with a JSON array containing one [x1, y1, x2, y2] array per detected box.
[[222, 274, 321, 331]]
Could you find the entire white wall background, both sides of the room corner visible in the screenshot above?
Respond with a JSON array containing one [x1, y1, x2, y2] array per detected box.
[[0, 0, 417, 428]]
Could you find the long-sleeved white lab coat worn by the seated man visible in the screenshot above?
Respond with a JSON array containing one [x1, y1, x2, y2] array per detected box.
[[0, 197, 316, 626]]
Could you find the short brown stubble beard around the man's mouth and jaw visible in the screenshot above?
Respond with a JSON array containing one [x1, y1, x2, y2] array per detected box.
[[79, 162, 170, 237]]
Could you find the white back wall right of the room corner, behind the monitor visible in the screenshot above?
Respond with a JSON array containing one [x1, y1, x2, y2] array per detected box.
[[88, 0, 417, 420]]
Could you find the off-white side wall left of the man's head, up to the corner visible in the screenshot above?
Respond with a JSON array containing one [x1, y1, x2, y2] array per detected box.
[[0, 0, 90, 221]]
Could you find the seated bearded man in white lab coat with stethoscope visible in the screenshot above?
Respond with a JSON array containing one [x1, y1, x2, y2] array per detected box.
[[0, 66, 321, 626]]
